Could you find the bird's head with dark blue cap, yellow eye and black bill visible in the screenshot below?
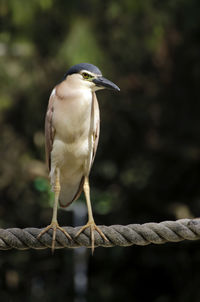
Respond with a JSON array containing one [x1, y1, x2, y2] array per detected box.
[[65, 63, 120, 91]]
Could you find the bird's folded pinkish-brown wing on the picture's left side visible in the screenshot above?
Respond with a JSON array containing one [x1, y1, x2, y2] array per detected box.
[[45, 90, 55, 171]]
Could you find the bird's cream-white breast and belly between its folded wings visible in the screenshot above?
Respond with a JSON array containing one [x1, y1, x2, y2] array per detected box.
[[51, 89, 92, 174]]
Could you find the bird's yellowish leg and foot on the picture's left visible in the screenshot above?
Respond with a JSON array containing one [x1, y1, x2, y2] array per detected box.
[[38, 169, 72, 252]]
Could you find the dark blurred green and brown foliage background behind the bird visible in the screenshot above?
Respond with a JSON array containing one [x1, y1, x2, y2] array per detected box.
[[0, 0, 200, 302]]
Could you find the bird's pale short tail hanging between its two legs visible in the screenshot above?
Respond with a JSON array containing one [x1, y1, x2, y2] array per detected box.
[[59, 176, 84, 208]]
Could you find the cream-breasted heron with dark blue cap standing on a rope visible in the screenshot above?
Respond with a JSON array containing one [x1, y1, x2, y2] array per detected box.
[[38, 63, 120, 253]]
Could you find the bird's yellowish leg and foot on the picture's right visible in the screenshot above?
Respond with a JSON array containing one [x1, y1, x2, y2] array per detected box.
[[76, 177, 108, 254]]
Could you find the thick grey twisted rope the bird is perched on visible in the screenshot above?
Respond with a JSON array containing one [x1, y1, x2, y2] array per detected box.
[[0, 218, 200, 250]]
